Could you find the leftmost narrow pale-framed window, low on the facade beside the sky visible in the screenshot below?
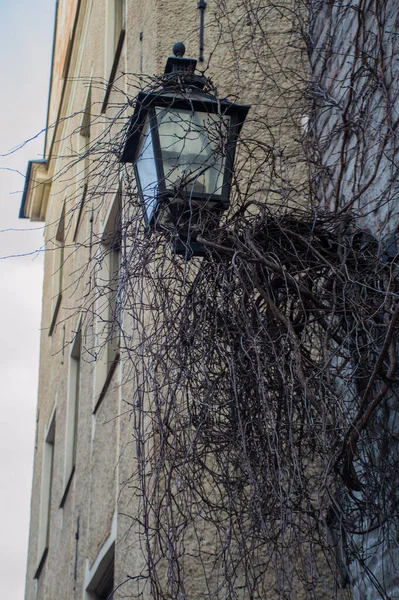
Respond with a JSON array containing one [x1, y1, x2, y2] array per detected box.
[[35, 412, 55, 579]]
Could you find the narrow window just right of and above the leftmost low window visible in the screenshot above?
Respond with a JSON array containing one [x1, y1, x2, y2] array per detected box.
[[60, 323, 82, 508]]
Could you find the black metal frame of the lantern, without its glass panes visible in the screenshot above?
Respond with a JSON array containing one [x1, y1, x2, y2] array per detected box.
[[121, 44, 250, 254]]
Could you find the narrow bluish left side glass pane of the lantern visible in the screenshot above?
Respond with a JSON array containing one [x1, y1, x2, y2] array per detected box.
[[136, 117, 158, 221]]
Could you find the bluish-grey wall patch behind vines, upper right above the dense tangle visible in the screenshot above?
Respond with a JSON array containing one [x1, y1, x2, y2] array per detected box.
[[310, 2, 399, 237]]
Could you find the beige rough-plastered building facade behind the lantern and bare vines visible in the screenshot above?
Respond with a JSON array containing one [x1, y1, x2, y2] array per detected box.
[[21, 0, 399, 600]]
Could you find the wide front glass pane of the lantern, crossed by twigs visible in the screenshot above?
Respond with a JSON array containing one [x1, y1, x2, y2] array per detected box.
[[156, 107, 230, 195]]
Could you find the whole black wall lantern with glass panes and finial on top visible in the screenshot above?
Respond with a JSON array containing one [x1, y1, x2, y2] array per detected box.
[[121, 43, 249, 257]]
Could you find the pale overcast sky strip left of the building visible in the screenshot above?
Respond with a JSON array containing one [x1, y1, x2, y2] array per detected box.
[[0, 0, 55, 600]]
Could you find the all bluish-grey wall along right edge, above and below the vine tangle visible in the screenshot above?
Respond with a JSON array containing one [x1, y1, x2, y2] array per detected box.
[[309, 0, 399, 600]]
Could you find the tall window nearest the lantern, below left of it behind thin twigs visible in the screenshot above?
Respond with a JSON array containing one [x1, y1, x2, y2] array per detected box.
[[94, 190, 121, 412]]
